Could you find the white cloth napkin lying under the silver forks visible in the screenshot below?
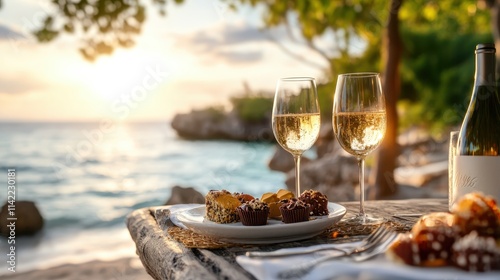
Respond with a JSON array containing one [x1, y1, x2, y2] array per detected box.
[[236, 244, 500, 280]]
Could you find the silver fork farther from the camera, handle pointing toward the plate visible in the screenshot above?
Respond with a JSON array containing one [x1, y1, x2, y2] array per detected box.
[[245, 226, 390, 258]]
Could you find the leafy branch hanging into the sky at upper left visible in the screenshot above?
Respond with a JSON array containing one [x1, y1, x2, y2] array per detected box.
[[32, 0, 174, 61]]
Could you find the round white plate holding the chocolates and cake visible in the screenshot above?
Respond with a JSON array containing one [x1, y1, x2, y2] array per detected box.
[[177, 202, 346, 244]]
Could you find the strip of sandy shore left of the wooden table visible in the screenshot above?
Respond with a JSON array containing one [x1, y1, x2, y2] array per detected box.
[[0, 257, 153, 280]]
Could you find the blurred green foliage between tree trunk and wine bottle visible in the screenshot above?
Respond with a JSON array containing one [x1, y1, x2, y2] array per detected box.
[[398, 0, 493, 133]]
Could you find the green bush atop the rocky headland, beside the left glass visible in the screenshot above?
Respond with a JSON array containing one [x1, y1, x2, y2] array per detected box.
[[230, 92, 273, 123]]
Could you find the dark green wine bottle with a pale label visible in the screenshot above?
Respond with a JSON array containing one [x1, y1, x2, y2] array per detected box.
[[453, 44, 500, 206]]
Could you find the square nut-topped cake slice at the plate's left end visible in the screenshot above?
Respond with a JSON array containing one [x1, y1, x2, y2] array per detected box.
[[205, 190, 241, 224]]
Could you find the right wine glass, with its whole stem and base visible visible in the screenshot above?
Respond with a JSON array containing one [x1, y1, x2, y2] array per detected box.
[[332, 73, 387, 224]]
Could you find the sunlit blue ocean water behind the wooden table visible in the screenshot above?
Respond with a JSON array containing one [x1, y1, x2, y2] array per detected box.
[[0, 122, 285, 274]]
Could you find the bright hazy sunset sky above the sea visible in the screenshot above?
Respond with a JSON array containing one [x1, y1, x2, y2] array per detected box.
[[0, 0, 327, 122]]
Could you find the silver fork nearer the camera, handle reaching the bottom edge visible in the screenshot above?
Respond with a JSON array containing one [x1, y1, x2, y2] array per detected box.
[[277, 229, 398, 280]]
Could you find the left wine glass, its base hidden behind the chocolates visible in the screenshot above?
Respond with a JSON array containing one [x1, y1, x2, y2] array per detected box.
[[272, 77, 321, 197]]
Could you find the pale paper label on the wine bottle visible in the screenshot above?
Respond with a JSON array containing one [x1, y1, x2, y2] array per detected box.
[[450, 156, 500, 206]]
